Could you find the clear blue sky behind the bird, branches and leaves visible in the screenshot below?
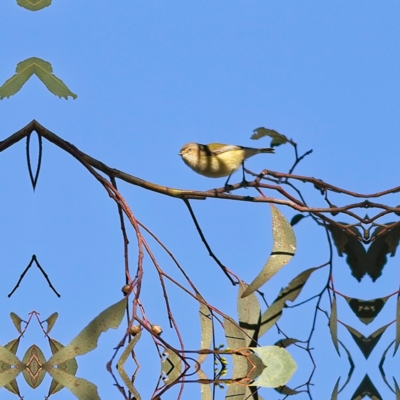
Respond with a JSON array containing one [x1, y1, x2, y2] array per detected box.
[[0, 0, 400, 399]]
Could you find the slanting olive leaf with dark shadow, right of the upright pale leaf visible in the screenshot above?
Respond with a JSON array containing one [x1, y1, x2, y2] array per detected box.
[[259, 267, 319, 337]]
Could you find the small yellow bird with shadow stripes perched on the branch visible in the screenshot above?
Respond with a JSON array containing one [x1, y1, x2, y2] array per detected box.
[[179, 143, 274, 186]]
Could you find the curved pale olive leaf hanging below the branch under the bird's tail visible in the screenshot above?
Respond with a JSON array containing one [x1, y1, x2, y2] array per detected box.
[[242, 204, 296, 297]]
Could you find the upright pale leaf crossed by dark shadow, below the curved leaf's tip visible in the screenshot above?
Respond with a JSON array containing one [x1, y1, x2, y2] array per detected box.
[[237, 282, 261, 347]]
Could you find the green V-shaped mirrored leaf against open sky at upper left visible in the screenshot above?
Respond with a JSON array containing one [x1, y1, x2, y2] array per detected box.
[[0, 57, 78, 100]]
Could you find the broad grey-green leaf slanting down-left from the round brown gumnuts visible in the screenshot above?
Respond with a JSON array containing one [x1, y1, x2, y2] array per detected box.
[[47, 297, 127, 366]]
